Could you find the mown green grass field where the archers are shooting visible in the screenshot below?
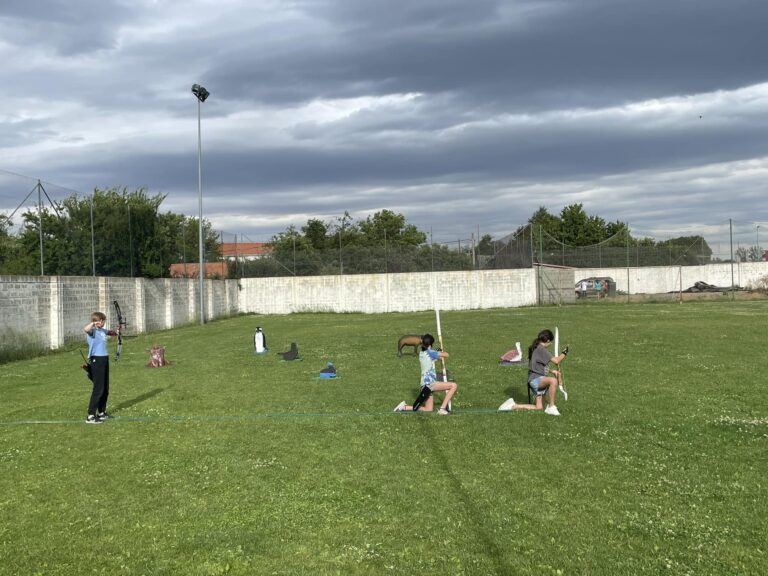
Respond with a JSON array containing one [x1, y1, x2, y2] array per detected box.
[[0, 301, 768, 576]]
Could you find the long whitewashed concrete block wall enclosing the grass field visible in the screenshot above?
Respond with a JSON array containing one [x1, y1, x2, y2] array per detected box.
[[0, 262, 768, 348]]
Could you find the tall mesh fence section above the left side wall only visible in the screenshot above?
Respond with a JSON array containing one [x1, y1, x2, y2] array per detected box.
[[0, 170, 226, 278]]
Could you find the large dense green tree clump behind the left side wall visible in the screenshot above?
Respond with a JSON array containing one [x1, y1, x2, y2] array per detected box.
[[4, 188, 219, 277]]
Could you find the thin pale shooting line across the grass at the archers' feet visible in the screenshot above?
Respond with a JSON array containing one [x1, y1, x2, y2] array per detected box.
[[0, 408, 503, 426]]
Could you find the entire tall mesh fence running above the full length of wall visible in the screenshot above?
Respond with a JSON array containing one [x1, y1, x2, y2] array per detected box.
[[0, 170, 768, 278]]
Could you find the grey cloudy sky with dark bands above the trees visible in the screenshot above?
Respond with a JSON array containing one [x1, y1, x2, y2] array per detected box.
[[0, 0, 768, 251]]
